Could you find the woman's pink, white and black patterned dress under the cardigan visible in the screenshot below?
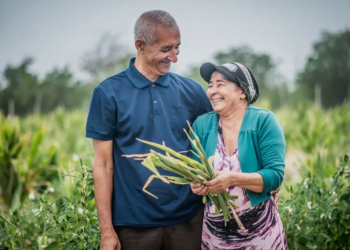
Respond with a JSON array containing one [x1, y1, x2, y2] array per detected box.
[[201, 121, 288, 250]]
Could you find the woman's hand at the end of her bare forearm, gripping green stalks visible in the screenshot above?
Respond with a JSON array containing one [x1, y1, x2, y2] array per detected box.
[[203, 171, 237, 194]]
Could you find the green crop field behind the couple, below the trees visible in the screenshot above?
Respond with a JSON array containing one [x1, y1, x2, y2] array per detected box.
[[0, 101, 350, 249]]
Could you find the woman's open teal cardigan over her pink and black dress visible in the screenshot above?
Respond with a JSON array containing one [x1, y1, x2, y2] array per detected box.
[[193, 106, 286, 206]]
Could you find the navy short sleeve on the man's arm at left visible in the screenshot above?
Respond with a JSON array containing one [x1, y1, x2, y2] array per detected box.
[[86, 88, 117, 141]]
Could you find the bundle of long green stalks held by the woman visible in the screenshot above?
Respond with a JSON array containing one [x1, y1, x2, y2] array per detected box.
[[125, 122, 244, 230]]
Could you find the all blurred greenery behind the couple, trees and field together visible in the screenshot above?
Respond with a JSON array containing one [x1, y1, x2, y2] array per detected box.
[[0, 30, 350, 249]]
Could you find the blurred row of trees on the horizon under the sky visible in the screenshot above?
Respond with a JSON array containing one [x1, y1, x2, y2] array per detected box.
[[0, 30, 350, 116]]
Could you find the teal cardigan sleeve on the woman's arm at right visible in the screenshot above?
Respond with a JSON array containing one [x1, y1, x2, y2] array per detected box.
[[258, 112, 286, 193]]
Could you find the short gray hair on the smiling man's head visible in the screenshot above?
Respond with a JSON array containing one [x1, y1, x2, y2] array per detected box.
[[134, 10, 178, 45]]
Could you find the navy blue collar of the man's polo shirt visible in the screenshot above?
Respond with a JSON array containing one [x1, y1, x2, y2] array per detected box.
[[125, 57, 170, 89]]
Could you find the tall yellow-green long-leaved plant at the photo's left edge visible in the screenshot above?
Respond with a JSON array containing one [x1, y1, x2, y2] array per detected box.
[[0, 116, 56, 210]]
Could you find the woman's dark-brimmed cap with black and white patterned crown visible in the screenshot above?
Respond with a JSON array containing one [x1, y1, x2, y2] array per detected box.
[[200, 62, 259, 104]]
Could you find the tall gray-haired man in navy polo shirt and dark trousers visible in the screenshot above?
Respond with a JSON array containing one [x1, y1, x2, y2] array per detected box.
[[86, 10, 211, 250]]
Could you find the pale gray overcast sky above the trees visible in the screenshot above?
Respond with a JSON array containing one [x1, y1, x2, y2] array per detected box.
[[0, 0, 350, 84]]
